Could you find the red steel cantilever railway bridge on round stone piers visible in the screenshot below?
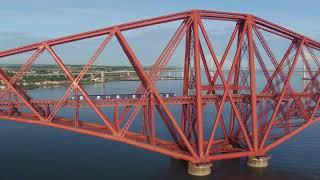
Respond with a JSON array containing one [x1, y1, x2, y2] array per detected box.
[[0, 10, 320, 175]]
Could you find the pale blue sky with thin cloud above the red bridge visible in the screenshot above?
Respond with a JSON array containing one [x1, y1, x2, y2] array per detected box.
[[0, 0, 320, 67]]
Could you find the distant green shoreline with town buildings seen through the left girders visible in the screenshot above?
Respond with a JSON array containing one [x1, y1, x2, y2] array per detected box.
[[0, 64, 181, 89]]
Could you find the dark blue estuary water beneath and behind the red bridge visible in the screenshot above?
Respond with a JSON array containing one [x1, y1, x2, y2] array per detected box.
[[0, 73, 320, 180]]
